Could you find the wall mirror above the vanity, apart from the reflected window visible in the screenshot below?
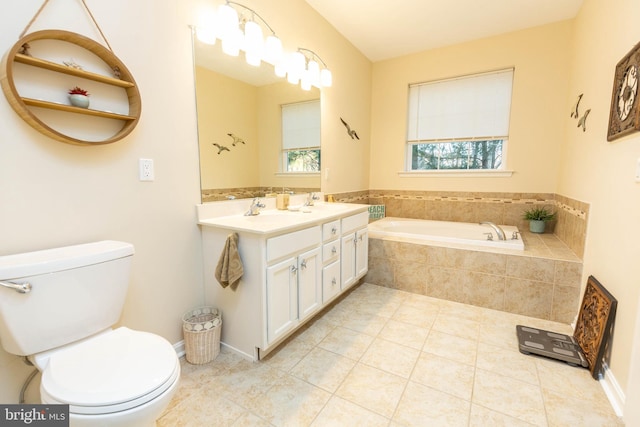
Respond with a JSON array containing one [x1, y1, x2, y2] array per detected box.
[[193, 37, 320, 203]]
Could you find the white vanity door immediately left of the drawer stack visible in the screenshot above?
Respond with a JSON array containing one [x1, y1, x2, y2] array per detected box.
[[298, 248, 322, 321]]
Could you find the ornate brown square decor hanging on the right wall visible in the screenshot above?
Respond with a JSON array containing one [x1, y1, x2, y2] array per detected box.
[[607, 43, 640, 141]]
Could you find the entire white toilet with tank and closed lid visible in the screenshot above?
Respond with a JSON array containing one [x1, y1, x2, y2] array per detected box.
[[0, 241, 180, 427]]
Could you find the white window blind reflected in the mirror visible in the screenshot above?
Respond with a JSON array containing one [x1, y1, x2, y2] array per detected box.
[[282, 100, 320, 150]]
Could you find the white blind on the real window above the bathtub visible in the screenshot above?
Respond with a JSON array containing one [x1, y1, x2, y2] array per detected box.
[[407, 69, 513, 143]]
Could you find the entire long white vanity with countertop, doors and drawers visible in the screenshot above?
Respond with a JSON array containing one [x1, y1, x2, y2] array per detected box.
[[199, 202, 368, 360]]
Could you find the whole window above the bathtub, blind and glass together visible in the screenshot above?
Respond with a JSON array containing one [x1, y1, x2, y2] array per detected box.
[[406, 69, 513, 171]]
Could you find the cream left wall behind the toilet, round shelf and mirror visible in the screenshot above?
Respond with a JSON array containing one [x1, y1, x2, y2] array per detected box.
[[0, 0, 371, 403]]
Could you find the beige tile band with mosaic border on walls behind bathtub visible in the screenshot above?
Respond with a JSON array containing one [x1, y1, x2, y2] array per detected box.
[[333, 190, 589, 258]]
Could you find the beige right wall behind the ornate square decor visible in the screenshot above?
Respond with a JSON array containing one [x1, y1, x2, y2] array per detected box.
[[557, 0, 640, 412]]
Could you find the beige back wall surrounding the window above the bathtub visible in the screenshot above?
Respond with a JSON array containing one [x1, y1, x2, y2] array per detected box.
[[370, 21, 572, 193]]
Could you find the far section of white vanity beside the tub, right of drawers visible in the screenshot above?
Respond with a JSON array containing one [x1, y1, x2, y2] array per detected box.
[[341, 212, 369, 290]]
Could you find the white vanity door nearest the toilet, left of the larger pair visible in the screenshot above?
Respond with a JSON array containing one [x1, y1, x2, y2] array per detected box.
[[267, 258, 298, 342]]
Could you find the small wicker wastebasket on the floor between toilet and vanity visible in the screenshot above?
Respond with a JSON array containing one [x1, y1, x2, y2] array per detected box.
[[182, 307, 222, 365]]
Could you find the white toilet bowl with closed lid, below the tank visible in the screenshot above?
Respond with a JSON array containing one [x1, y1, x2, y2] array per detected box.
[[30, 327, 180, 427]]
